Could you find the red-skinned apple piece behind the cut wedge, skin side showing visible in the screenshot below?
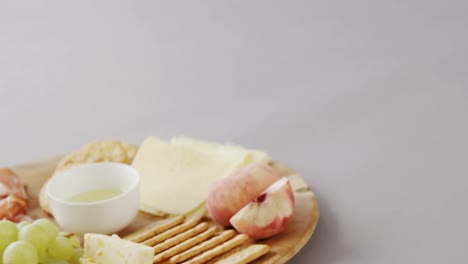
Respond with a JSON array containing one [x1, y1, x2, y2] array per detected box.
[[207, 162, 281, 226]]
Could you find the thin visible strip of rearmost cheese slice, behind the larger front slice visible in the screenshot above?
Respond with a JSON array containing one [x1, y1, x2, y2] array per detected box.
[[171, 136, 271, 165]]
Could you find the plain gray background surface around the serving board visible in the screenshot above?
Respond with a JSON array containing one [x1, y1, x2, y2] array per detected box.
[[0, 0, 468, 263]]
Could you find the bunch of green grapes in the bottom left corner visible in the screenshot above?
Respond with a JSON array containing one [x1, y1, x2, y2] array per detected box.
[[0, 219, 83, 264]]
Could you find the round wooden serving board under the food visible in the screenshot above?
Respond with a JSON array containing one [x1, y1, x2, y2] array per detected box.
[[12, 157, 319, 264]]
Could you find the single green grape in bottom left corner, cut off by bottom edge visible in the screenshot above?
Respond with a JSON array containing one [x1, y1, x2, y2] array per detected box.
[[3, 241, 37, 264]]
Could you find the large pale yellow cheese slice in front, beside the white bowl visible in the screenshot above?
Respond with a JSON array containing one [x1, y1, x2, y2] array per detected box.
[[132, 137, 246, 214]]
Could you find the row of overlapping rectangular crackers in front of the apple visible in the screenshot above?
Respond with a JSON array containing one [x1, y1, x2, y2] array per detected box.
[[124, 216, 270, 264]]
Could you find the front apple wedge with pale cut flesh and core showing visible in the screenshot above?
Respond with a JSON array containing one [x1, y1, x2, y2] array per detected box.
[[230, 177, 295, 239]]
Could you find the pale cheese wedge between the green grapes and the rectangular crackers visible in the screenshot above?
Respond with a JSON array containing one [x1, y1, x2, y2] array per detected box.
[[81, 234, 154, 264]]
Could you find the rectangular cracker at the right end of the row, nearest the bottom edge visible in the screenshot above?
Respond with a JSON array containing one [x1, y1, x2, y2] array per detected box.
[[209, 244, 270, 264]]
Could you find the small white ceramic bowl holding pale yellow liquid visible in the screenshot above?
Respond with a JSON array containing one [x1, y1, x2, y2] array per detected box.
[[47, 162, 140, 234]]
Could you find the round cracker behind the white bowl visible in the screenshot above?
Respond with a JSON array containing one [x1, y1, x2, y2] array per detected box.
[[39, 140, 138, 215]]
